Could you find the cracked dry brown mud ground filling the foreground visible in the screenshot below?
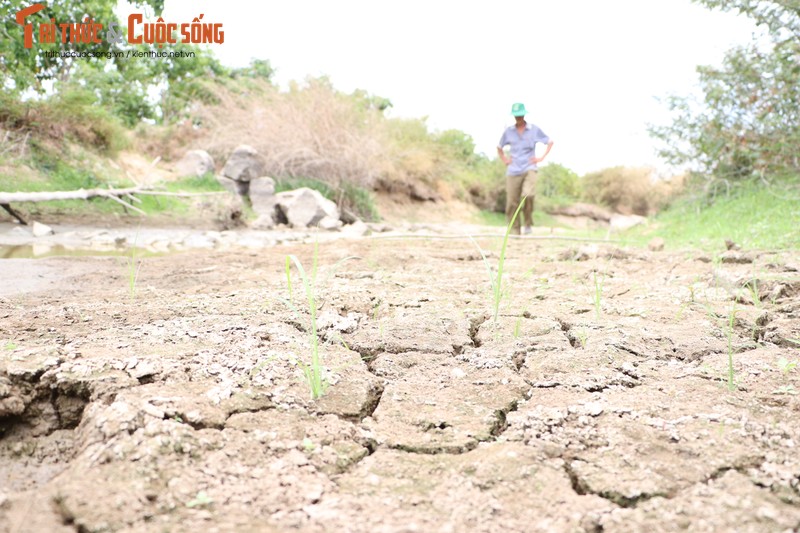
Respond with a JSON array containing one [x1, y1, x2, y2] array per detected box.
[[0, 239, 800, 532]]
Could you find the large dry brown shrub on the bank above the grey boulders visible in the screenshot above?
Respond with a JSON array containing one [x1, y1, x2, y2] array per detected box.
[[194, 79, 387, 186]]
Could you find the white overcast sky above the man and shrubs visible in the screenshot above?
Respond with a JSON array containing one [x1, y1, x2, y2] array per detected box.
[[136, 0, 754, 173]]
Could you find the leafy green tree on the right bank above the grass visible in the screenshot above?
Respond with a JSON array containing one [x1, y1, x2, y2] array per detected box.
[[650, 0, 800, 185]]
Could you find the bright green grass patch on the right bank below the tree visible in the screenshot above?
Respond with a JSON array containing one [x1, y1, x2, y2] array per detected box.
[[626, 182, 800, 250]]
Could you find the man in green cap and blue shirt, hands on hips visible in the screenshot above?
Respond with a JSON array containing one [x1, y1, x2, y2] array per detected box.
[[497, 103, 553, 235]]
